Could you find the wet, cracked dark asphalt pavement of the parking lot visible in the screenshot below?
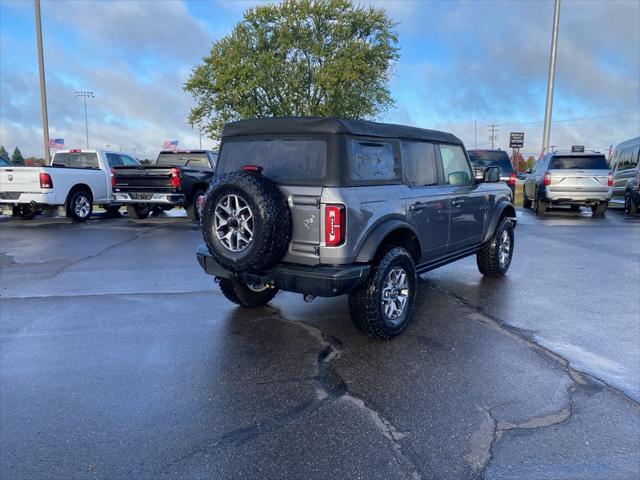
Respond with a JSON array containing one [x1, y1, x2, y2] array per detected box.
[[0, 207, 640, 480]]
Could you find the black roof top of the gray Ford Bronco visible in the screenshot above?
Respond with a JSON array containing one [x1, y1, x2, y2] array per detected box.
[[222, 117, 462, 145]]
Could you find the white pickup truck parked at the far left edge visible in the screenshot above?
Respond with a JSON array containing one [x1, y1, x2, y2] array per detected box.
[[0, 149, 139, 222]]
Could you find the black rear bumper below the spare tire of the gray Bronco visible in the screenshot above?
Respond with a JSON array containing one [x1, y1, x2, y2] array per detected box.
[[196, 245, 371, 297]]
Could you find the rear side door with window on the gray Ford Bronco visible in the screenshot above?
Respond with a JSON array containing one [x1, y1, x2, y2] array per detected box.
[[401, 140, 449, 262]]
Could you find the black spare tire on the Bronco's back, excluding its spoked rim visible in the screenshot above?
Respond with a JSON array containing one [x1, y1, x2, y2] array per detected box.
[[200, 172, 291, 272]]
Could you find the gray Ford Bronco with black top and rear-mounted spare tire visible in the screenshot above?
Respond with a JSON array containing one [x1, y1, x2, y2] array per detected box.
[[197, 117, 516, 339]]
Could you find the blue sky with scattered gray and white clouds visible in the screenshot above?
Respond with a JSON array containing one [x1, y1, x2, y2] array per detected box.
[[0, 0, 640, 158]]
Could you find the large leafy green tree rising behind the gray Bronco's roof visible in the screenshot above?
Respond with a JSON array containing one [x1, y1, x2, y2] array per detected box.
[[184, 0, 399, 137]]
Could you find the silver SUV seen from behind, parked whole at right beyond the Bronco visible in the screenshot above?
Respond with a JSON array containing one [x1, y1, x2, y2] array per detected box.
[[523, 152, 613, 216]]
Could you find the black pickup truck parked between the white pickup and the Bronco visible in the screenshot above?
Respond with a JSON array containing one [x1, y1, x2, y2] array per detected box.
[[111, 150, 218, 222]]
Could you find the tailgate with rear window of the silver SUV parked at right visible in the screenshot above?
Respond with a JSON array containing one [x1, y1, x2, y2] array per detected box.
[[547, 155, 609, 197]]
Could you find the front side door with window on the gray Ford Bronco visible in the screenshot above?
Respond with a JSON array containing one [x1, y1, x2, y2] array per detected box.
[[439, 144, 487, 253]]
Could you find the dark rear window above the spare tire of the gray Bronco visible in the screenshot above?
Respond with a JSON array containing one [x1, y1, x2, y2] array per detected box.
[[218, 139, 327, 183]]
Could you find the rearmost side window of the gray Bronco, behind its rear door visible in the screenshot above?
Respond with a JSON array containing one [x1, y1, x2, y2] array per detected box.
[[348, 140, 400, 182]]
